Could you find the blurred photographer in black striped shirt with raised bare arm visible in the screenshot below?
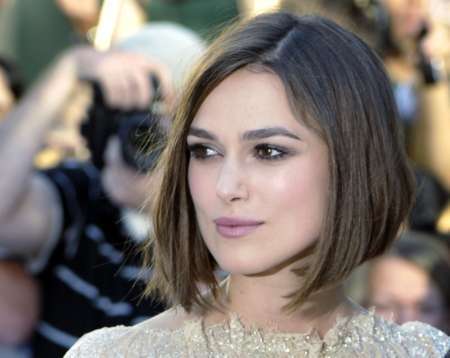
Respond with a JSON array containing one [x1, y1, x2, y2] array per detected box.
[[0, 25, 204, 357]]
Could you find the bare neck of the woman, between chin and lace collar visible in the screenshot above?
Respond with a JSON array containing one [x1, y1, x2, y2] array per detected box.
[[211, 273, 357, 336]]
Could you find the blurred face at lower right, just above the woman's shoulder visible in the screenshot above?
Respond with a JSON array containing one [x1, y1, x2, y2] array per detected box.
[[367, 257, 447, 329]]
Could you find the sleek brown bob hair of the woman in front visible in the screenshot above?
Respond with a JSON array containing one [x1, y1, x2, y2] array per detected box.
[[144, 12, 414, 311]]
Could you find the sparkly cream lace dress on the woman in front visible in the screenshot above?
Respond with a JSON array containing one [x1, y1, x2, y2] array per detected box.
[[65, 311, 450, 358]]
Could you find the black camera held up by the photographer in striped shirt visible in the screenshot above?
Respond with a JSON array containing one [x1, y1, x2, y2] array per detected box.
[[81, 75, 165, 173]]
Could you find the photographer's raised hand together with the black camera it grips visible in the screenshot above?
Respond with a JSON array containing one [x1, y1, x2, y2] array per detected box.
[[59, 47, 174, 172]]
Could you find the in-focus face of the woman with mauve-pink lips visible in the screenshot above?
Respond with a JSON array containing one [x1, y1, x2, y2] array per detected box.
[[187, 69, 329, 275]]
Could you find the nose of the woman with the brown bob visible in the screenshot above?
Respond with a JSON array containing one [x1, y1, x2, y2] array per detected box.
[[216, 159, 248, 203]]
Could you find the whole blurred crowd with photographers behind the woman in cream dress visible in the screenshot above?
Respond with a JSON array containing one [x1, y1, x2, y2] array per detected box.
[[0, 0, 450, 358]]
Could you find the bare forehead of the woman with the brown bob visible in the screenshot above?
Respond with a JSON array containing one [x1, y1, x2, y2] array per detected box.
[[192, 68, 303, 133]]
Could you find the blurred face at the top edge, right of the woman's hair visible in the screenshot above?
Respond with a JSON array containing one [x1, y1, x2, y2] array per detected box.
[[381, 0, 428, 41]]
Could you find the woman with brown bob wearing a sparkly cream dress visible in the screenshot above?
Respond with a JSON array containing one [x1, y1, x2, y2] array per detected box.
[[67, 13, 450, 357]]
